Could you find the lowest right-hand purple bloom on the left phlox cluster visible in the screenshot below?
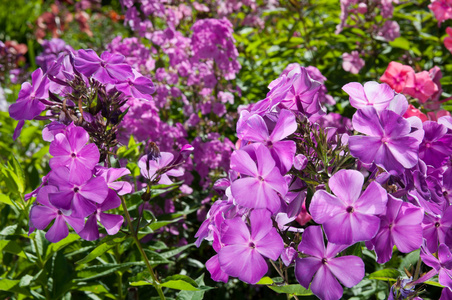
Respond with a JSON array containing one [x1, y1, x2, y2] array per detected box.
[[79, 189, 124, 241]]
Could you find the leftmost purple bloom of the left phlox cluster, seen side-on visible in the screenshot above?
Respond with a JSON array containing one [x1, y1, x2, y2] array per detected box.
[[9, 68, 49, 120]]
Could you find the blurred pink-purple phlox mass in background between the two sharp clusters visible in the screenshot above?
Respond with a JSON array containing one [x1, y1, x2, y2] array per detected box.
[[108, 1, 244, 188]]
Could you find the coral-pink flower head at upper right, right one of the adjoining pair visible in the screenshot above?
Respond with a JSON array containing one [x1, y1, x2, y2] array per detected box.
[[403, 71, 438, 103]]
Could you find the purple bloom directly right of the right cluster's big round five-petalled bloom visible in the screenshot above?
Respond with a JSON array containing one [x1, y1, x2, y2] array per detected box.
[[366, 195, 424, 264]]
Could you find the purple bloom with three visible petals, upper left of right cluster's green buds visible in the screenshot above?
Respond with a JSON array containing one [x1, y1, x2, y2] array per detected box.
[[237, 109, 297, 174]]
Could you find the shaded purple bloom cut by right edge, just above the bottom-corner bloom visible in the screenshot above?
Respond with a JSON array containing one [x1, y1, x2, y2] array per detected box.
[[422, 206, 452, 253]]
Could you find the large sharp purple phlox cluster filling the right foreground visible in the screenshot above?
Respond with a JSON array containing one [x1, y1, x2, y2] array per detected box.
[[196, 61, 452, 300]]
